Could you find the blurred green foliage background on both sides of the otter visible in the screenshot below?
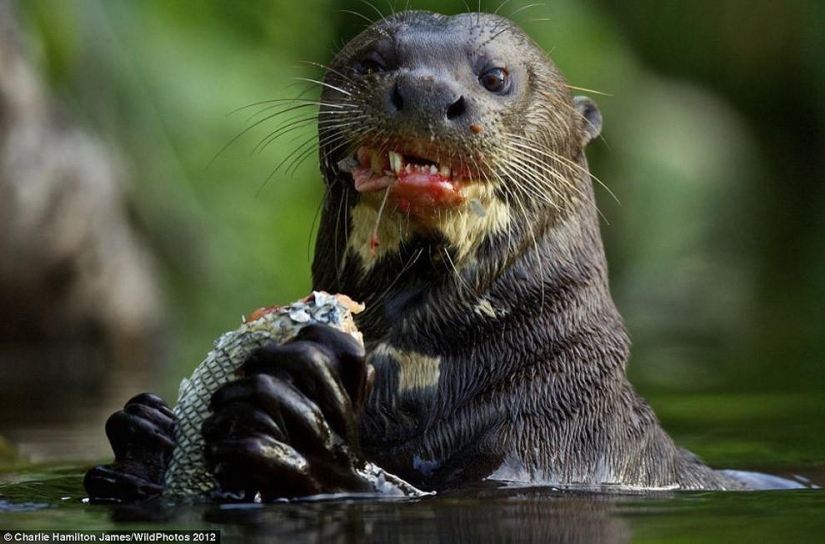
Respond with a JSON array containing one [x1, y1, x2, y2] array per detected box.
[[3, 0, 825, 463]]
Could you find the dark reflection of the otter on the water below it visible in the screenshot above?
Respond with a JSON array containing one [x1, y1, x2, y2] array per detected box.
[[112, 488, 638, 544]]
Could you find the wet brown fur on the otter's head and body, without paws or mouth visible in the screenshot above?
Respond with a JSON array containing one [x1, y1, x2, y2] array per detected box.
[[313, 12, 739, 489]]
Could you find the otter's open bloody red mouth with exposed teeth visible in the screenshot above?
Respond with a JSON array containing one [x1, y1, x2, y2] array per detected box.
[[342, 147, 470, 212]]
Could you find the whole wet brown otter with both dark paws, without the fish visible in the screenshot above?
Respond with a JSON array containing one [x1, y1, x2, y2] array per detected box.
[[86, 11, 745, 500]]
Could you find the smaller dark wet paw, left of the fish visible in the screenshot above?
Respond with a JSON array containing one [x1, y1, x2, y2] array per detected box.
[[83, 393, 175, 502]]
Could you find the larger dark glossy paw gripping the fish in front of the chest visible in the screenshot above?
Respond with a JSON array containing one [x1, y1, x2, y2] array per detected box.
[[202, 325, 371, 500]]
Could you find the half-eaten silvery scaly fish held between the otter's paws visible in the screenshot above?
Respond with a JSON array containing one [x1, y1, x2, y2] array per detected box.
[[164, 291, 364, 499]]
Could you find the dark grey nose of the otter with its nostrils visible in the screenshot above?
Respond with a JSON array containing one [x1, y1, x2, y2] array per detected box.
[[389, 72, 467, 121]]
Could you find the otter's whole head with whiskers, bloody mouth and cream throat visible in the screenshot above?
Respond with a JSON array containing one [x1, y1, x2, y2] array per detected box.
[[319, 11, 601, 276]]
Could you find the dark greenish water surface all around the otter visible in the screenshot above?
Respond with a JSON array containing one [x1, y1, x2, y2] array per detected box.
[[0, 392, 825, 544]]
